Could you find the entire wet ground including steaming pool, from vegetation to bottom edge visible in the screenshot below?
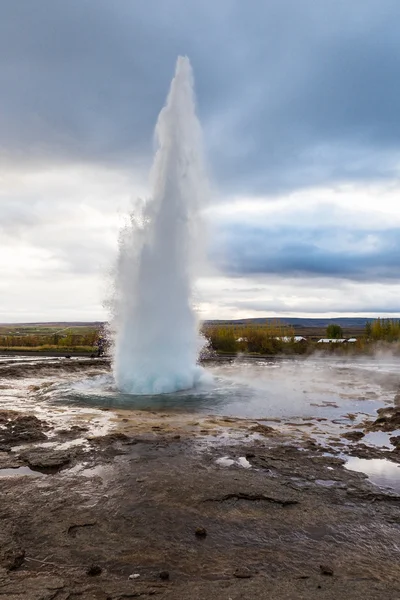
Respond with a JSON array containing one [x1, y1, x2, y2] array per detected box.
[[0, 359, 400, 600]]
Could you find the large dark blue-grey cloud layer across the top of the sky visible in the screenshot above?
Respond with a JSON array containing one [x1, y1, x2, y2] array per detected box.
[[0, 0, 400, 193]]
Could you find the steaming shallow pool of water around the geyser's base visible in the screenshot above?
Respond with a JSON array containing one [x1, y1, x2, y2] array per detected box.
[[36, 359, 400, 424]]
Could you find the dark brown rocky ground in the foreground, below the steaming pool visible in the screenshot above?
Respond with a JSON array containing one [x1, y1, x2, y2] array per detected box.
[[0, 358, 400, 600]]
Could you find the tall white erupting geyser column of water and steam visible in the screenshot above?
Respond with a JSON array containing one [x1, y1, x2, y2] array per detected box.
[[114, 57, 207, 394]]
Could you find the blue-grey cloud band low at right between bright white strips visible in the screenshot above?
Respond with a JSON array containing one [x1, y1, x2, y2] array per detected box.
[[211, 225, 400, 281]]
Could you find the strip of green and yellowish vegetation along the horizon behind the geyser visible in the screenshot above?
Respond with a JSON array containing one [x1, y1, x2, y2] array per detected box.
[[0, 319, 400, 355]]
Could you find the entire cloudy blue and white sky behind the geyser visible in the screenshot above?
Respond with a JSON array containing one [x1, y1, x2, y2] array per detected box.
[[0, 0, 400, 322]]
